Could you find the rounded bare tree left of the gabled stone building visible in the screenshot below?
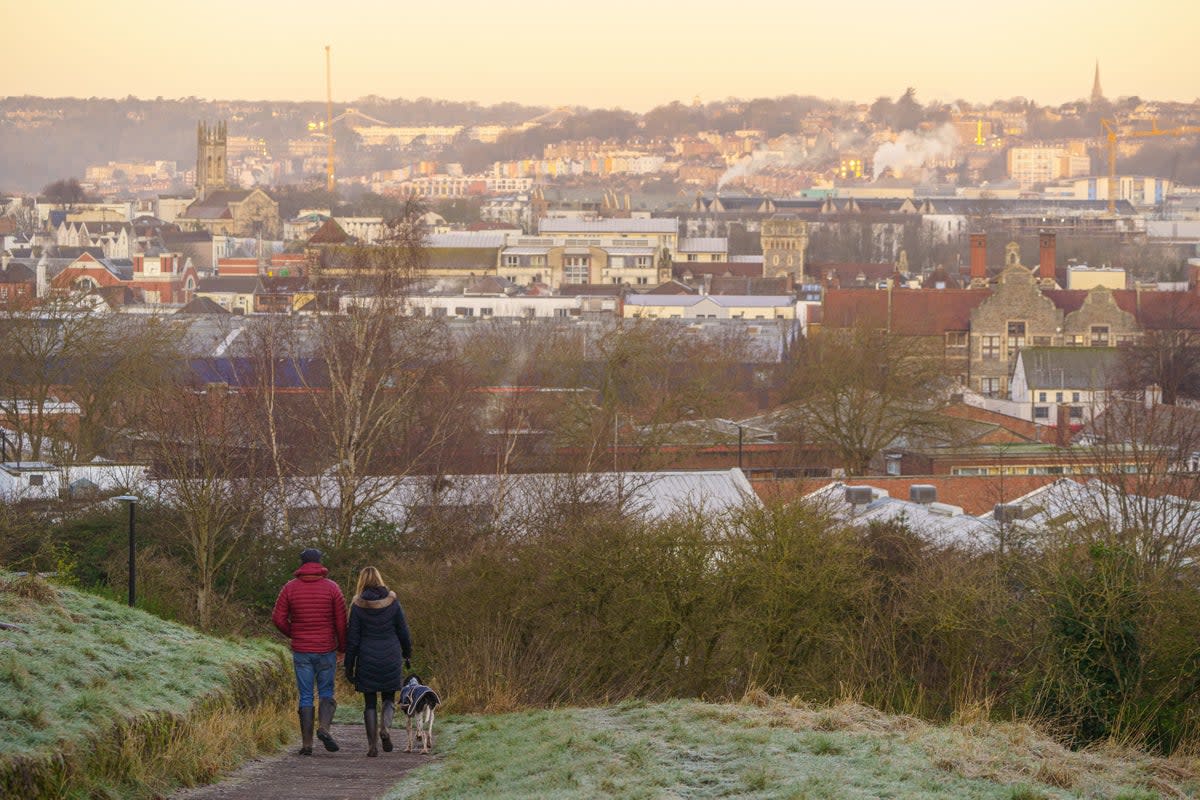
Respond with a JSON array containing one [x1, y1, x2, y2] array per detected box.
[[784, 327, 948, 475]]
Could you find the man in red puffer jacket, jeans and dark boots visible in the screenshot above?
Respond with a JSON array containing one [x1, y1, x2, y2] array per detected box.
[[271, 547, 346, 756]]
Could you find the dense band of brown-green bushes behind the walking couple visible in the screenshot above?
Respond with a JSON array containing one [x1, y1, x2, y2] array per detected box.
[[9, 475, 1200, 752]]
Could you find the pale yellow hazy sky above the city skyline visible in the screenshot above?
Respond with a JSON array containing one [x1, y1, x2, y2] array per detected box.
[[0, 0, 1200, 112]]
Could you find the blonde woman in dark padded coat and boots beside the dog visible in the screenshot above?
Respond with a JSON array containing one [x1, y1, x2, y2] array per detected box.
[[346, 566, 413, 756]]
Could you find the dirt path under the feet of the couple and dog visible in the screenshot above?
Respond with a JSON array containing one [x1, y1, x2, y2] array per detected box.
[[172, 724, 430, 800]]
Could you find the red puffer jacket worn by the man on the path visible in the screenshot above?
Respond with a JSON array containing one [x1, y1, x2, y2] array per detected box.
[[271, 563, 346, 652]]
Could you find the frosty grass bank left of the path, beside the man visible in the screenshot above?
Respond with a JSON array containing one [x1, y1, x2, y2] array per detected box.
[[0, 575, 295, 798]]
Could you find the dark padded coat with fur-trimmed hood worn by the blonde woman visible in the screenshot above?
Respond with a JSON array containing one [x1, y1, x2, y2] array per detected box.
[[346, 587, 413, 692]]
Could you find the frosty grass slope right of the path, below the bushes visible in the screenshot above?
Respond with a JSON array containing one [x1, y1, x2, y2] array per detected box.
[[386, 698, 1200, 800]]
